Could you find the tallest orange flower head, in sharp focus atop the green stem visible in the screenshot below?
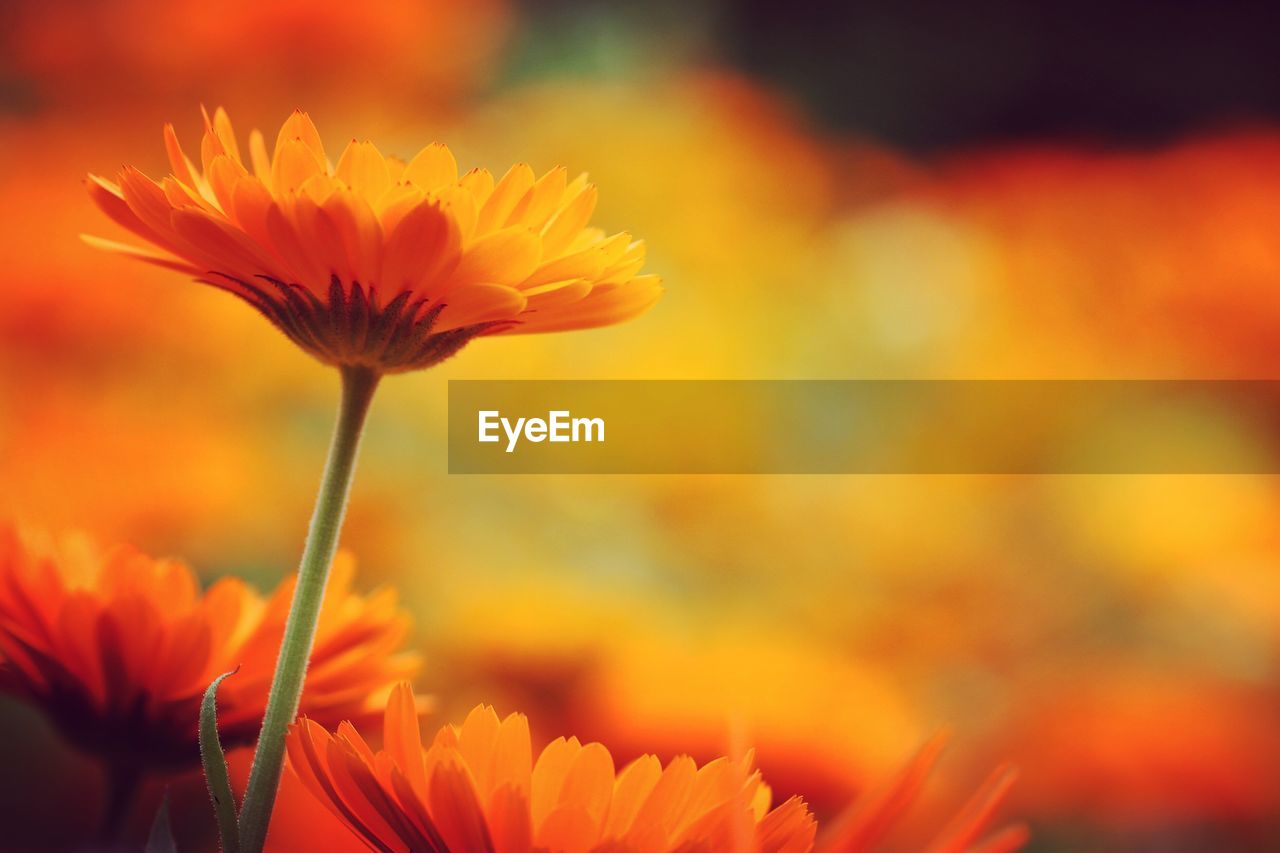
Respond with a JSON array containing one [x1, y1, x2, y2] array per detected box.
[[88, 109, 662, 373]]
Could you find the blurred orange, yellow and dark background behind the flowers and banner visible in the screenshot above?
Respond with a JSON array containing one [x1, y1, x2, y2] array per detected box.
[[0, 0, 1280, 850]]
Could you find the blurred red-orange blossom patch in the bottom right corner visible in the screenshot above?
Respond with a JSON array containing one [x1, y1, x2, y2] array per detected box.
[[992, 662, 1280, 829]]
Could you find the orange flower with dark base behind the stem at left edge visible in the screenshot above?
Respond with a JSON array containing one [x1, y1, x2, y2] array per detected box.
[[0, 528, 419, 768]]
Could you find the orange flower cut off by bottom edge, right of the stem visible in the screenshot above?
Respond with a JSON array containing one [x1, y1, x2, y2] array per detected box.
[[288, 685, 815, 853]]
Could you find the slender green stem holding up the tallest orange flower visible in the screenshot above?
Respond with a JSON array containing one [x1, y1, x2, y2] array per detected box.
[[239, 368, 379, 853]]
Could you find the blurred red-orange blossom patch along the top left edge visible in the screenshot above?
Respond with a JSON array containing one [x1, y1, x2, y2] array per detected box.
[[4, 0, 508, 108]]
